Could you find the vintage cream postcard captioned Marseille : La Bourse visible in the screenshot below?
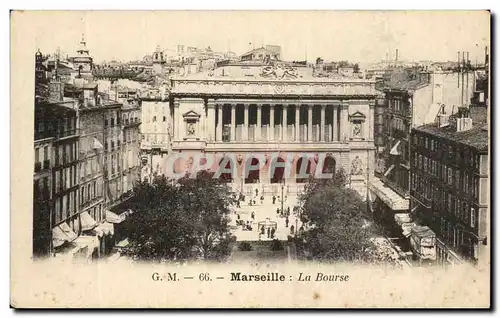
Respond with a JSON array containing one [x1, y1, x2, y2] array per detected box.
[[10, 11, 492, 308]]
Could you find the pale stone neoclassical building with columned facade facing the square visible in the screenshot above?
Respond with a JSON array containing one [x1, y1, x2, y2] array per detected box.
[[163, 63, 376, 195]]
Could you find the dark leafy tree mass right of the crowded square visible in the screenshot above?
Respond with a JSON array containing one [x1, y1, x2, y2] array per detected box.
[[299, 170, 374, 262]]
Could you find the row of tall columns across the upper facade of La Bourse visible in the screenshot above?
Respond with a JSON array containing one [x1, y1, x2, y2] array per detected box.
[[206, 100, 349, 142]]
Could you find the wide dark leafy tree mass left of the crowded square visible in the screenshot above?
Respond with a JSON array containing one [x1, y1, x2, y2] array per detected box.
[[123, 172, 236, 261]]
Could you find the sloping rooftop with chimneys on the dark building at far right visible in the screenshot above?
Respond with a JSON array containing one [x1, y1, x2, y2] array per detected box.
[[415, 118, 489, 151]]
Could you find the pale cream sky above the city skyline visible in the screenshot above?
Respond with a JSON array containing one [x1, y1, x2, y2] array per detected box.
[[12, 11, 490, 63]]
